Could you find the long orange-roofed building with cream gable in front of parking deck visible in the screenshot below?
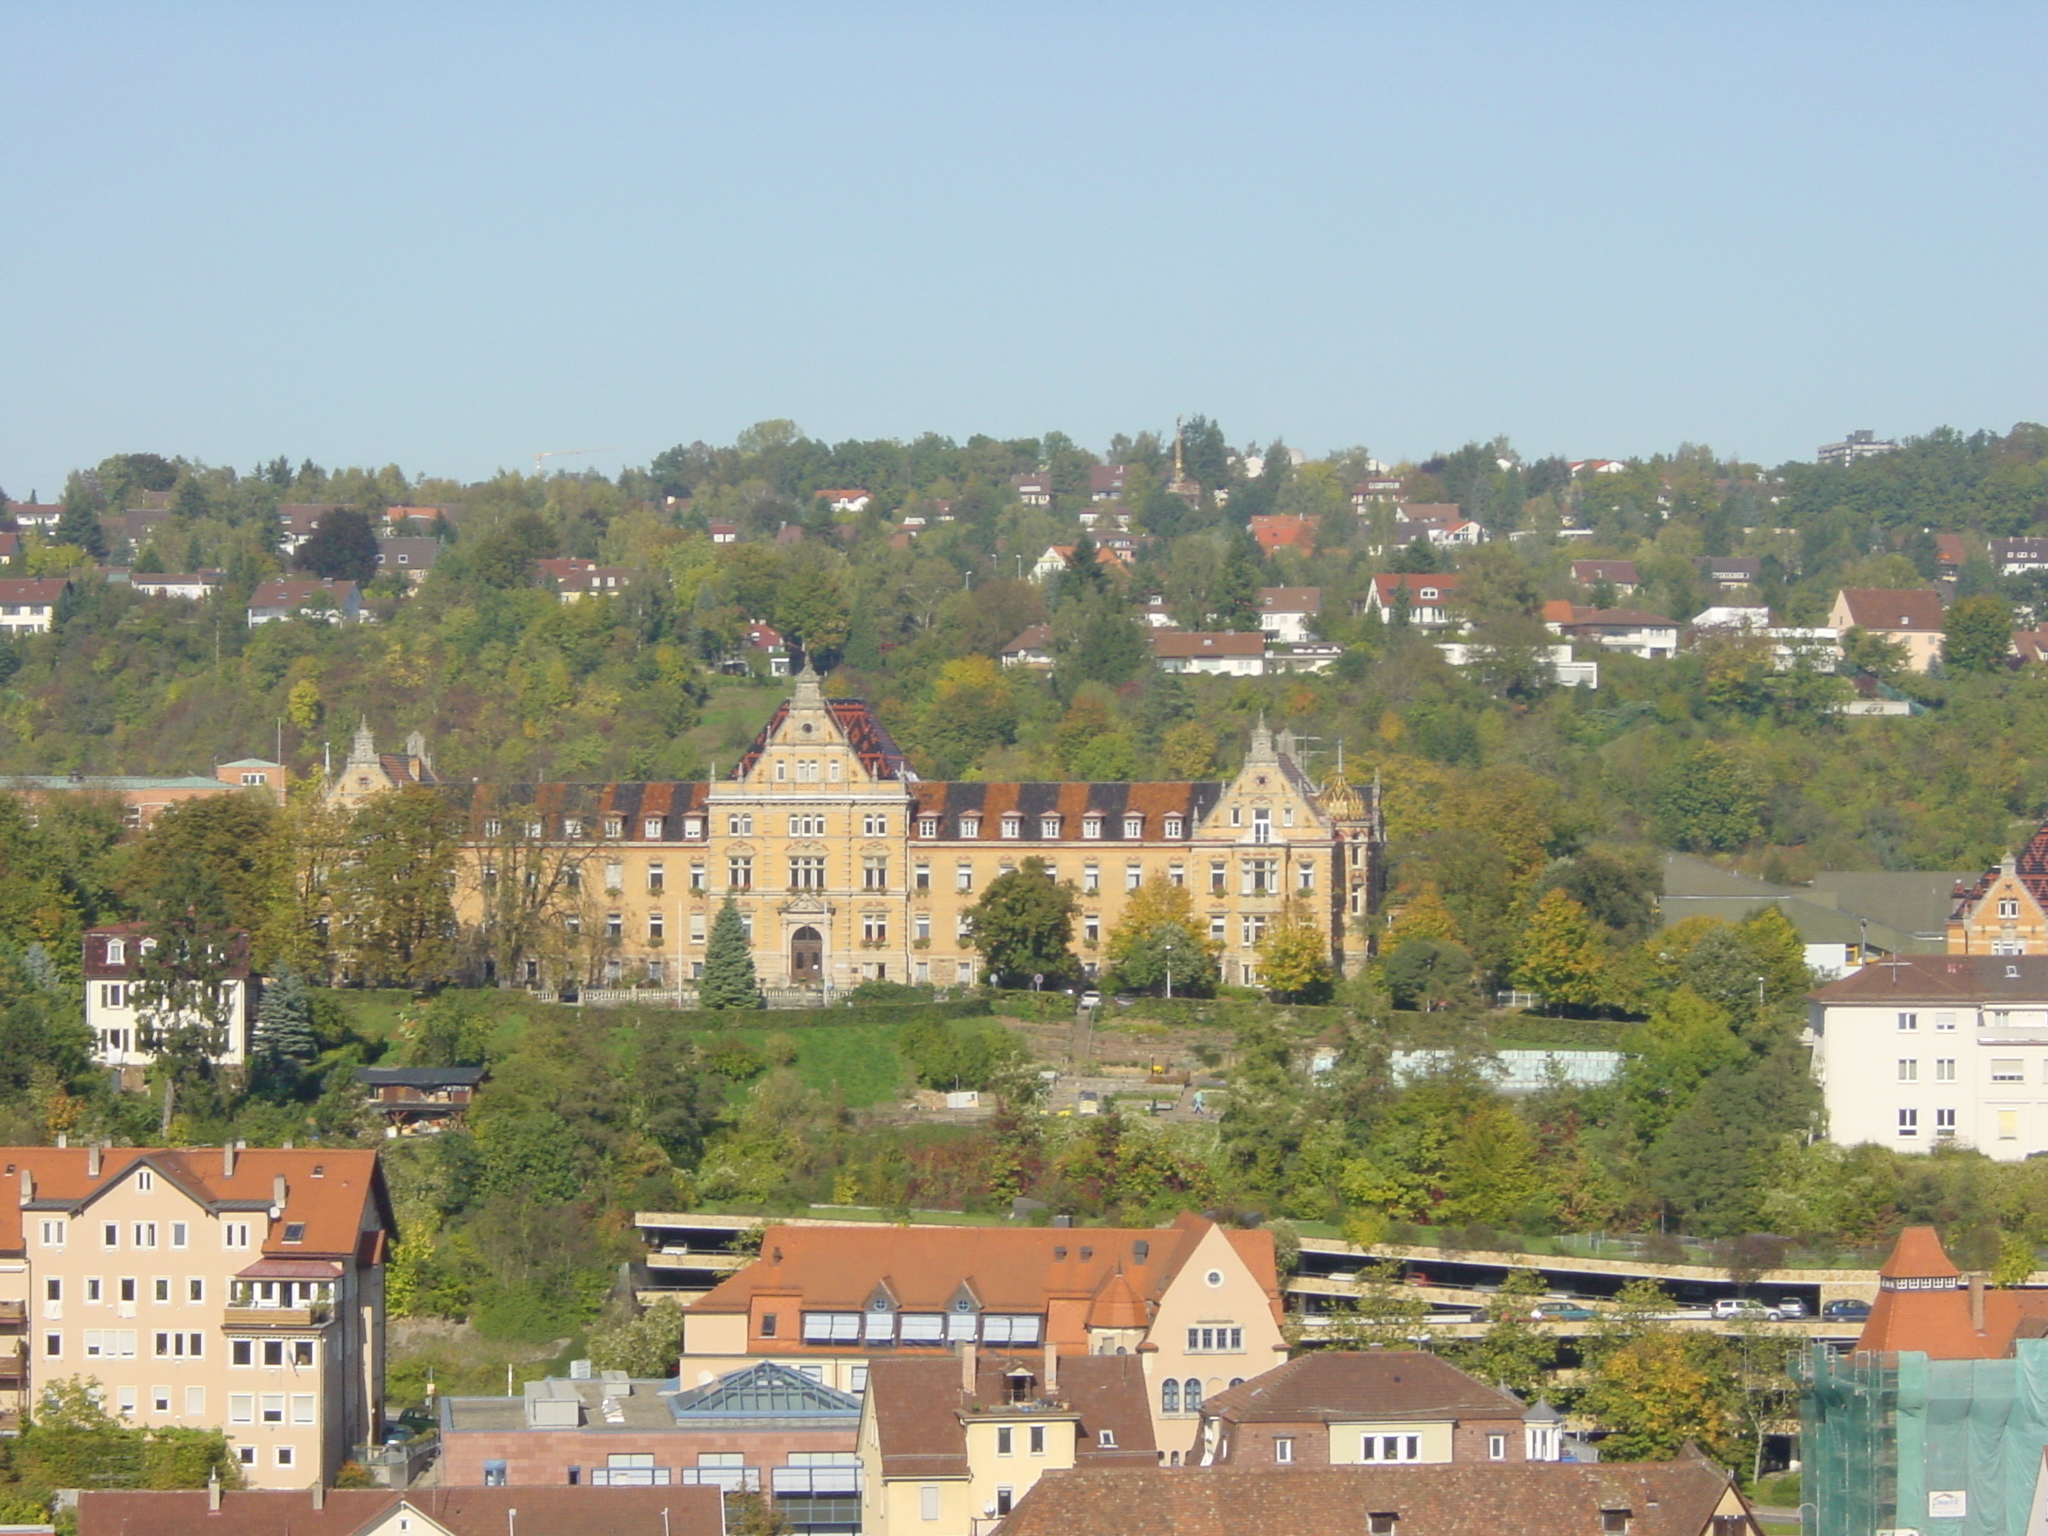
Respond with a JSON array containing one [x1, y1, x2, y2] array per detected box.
[[680, 1214, 1286, 1454]]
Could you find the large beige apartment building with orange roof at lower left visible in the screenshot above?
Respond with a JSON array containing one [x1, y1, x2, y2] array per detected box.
[[0, 1147, 393, 1489]]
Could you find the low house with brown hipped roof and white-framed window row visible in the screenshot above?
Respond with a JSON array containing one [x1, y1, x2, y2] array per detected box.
[[1198, 1350, 1563, 1466]]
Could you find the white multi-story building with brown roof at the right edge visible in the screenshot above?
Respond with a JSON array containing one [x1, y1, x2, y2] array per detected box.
[[1808, 954, 2048, 1163]]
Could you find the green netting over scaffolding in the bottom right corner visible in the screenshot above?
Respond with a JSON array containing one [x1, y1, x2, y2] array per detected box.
[[1800, 1339, 2048, 1536]]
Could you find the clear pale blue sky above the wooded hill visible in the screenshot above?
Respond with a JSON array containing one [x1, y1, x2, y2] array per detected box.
[[0, 0, 2048, 500]]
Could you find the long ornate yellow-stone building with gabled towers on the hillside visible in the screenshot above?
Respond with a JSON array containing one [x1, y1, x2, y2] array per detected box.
[[397, 672, 1380, 995]]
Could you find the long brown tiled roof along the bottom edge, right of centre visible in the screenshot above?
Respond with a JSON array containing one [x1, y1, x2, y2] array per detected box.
[[1001, 1454, 1761, 1536]]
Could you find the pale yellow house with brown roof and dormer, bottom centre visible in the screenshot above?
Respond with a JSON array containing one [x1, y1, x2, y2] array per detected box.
[[860, 1346, 1161, 1536]]
